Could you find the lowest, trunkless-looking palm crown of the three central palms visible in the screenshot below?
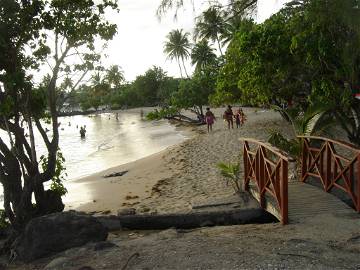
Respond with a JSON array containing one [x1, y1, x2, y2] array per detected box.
[[191, 40, 216, 70]]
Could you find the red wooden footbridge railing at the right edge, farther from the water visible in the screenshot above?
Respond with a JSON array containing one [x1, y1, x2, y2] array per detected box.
[[298, 136, 360, 212]]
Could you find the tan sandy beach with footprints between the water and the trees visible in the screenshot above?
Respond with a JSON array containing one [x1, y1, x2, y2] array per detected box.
[[65, 108, 291, 214]]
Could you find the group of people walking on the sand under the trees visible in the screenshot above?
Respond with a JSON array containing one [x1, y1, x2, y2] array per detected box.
[[205, 105, 246, 132]]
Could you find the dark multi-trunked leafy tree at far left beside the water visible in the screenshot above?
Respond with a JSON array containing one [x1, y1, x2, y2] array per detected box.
[[0, 0, 117, 234]]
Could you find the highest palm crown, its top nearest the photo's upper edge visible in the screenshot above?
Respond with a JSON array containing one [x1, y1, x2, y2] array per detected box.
[[194, 7, 226, 55]]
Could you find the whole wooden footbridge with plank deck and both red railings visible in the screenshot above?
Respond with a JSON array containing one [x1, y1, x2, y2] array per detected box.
[[240, 136, 360, 224]]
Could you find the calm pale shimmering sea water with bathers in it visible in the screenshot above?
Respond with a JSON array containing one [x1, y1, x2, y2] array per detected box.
[[0, 111, 186, 206]]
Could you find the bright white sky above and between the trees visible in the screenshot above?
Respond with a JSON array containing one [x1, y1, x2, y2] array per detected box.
[[104, 0, 286, 81]]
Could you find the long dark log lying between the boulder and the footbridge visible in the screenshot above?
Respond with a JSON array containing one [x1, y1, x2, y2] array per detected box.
[[96, 208, 275, 231]]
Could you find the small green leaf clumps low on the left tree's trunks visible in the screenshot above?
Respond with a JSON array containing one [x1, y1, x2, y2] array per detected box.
[[40, 150, 67, 196]]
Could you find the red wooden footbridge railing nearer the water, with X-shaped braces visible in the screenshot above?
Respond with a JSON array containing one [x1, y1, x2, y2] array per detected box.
[[240, 138, 289, 224]]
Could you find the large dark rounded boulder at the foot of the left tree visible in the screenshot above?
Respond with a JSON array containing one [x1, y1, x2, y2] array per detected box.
[[13, 212, 107, 262]]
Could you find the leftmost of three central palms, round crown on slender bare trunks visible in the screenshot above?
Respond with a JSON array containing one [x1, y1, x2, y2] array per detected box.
[[164, 29, 191, 77]]
